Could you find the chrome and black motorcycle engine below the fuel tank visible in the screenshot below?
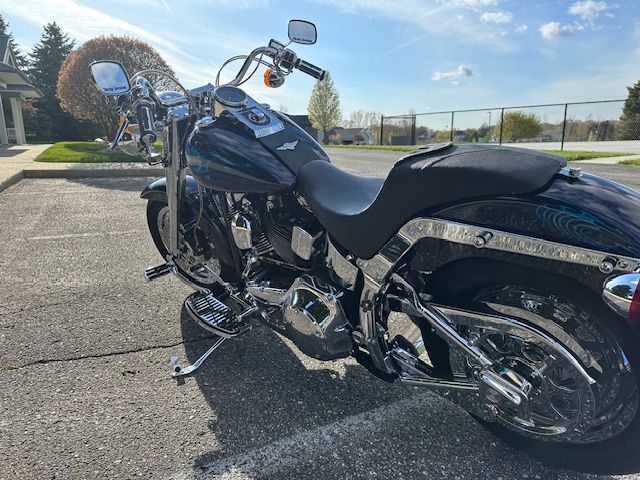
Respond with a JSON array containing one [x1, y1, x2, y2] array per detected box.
[[224, 191, 352, 360]]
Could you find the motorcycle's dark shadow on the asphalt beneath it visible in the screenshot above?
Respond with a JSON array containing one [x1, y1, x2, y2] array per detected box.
[[176, 309, 613, 480]]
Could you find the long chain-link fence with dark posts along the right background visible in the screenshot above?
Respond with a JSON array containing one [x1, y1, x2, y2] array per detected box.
[[376, 100, 640, 154]]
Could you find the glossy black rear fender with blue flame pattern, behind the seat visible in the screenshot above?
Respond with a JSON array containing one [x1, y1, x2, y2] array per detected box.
[[420, 174, 640, 295]]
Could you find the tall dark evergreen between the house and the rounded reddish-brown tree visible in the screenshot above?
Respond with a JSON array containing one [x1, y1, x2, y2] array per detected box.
[[27, 22, 99, 140]]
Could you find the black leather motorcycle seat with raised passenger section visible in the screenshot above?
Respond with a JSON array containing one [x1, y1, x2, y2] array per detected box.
[[298, 144, 566, 258]]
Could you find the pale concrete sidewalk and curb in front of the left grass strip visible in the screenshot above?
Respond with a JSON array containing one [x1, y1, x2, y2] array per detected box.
[[0, 144, 164, 192]]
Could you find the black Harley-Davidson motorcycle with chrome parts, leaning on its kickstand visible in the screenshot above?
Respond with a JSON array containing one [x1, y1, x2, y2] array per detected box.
[[90, 20, 640, 473]]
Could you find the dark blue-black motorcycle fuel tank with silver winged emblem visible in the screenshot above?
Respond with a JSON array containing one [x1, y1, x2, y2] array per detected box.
[[185, 111, 329, 193]]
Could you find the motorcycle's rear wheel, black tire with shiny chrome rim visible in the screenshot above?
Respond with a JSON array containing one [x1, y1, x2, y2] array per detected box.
[[430, 267, 640, 473]]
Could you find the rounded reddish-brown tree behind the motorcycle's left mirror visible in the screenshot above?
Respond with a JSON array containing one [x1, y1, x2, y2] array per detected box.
[[57, 35, 175, 136]]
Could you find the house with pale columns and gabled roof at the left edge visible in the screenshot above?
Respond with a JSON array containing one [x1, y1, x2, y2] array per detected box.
[[0, 35, 42, 145]]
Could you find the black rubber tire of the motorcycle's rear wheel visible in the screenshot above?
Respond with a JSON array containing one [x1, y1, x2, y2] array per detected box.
[[436, 264, 640, 474]]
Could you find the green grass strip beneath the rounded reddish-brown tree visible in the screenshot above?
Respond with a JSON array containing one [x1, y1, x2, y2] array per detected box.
[[35, 142, 144, 163]]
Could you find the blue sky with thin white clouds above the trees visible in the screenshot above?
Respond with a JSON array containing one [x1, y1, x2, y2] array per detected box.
[[0, 0, 640, 117]]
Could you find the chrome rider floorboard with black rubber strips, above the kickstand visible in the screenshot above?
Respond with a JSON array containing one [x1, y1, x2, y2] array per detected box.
[[184, 292, 257, 338]]
